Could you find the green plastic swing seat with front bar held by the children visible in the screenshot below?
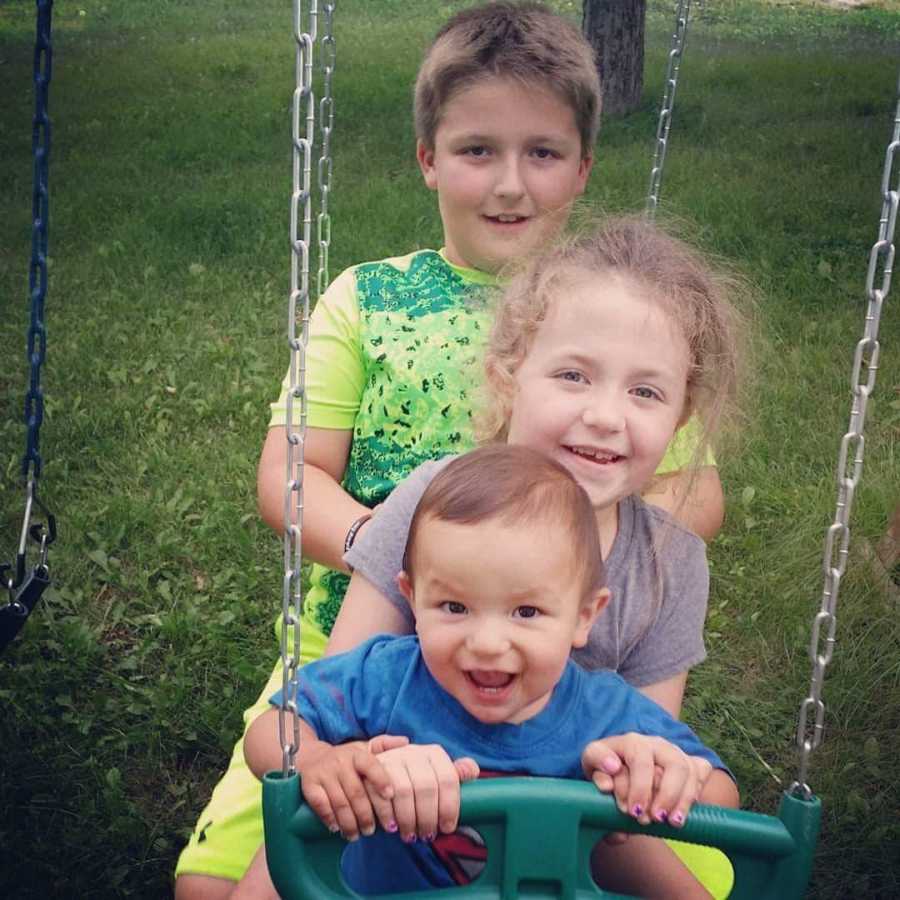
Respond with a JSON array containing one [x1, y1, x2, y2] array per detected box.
[[263, 772, 821, 900]]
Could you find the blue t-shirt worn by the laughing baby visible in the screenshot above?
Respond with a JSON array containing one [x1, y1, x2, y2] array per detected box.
[[271, 635, 727, 894]]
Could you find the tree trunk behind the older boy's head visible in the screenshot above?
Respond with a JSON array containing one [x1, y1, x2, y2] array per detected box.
[[582, 0, 645, 116]]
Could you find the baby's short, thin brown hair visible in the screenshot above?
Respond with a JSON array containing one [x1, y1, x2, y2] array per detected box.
[[403, 444, 606, 599]]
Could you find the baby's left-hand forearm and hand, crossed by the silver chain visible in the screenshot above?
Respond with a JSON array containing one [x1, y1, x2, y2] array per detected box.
[[244, 709, 408, 841]]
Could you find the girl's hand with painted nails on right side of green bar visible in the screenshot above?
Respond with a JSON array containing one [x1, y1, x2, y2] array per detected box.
[[581, 733, 712, 828]]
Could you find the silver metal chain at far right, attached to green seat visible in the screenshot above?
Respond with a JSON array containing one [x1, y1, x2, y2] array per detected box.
[[790, 72, 900, 800]]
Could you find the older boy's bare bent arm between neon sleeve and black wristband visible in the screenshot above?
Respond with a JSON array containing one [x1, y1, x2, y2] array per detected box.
[[256, 425, 369, 572]]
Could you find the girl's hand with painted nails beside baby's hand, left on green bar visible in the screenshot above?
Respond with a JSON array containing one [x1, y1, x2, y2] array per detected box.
[[369, 744, 479, 843]]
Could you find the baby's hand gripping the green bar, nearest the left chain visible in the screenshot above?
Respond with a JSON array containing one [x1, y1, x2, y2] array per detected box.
[[300, 734, 409, 841]]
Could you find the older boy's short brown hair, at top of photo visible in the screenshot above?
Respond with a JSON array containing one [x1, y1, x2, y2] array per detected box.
[[414, 2, 600, 157]]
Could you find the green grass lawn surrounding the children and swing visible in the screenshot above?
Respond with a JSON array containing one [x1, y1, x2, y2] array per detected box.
[[0, 0, 900, 900]]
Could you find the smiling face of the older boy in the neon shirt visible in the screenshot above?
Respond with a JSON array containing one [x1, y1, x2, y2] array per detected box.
[[416, 77, 592, 272]]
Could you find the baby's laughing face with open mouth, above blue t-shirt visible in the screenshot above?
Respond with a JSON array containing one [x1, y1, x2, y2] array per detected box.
[[399, 516, 609, 723]]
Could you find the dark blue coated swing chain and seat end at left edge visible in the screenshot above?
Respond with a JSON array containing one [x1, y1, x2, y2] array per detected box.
[[0, 0, 56, 648]]
